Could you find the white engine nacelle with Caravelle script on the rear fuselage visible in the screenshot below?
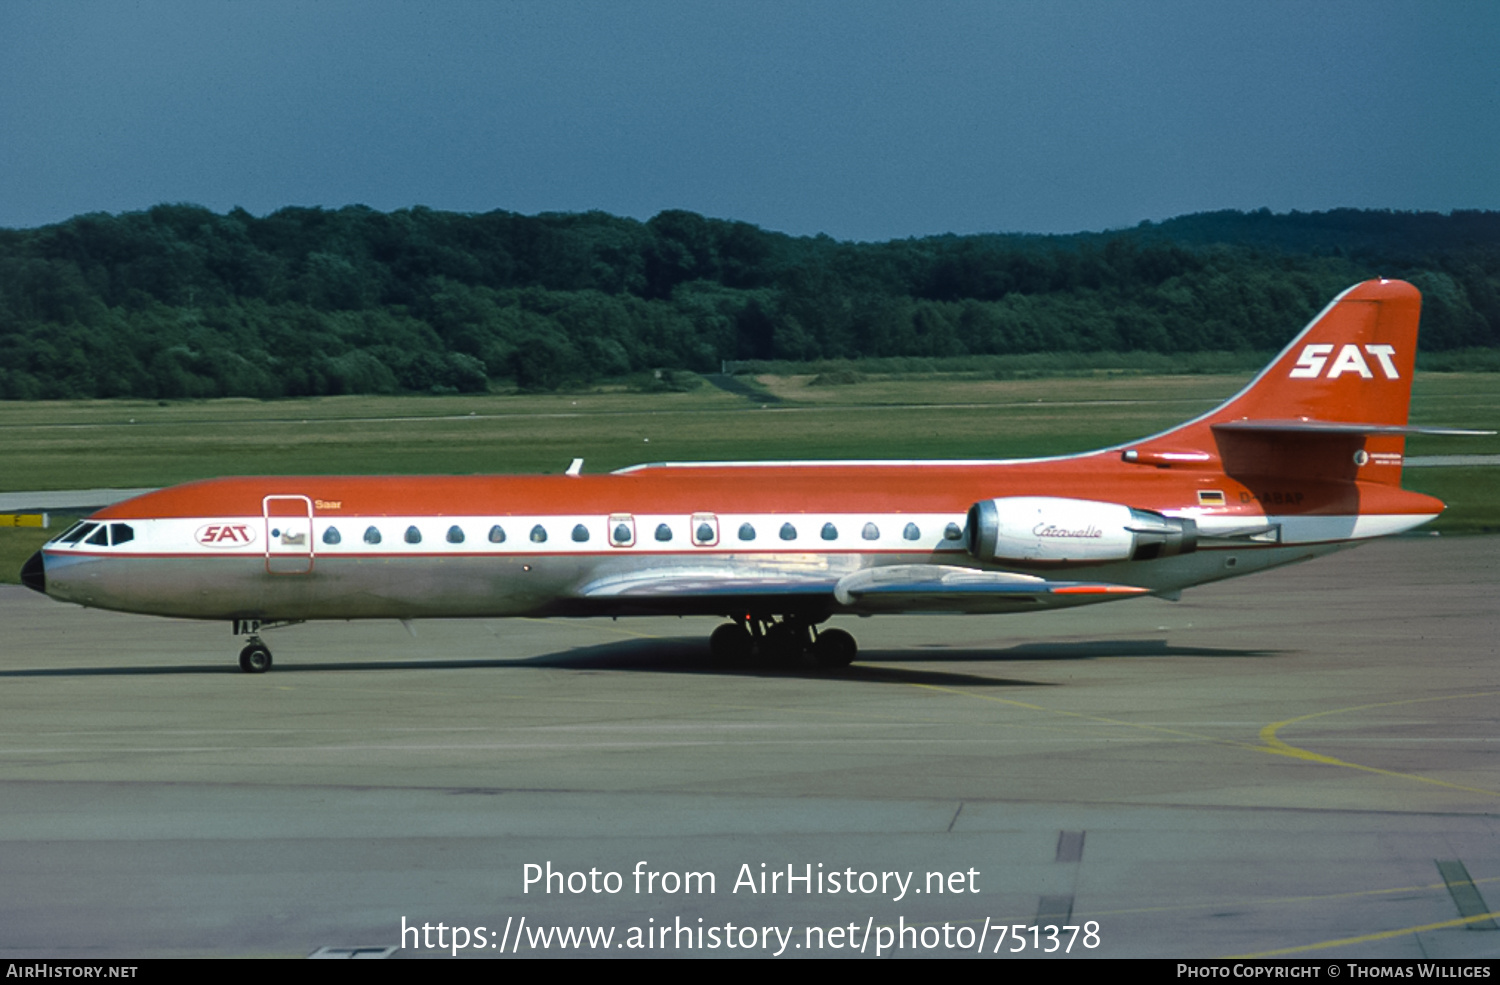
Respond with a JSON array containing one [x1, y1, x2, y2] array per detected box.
[[966, 496, 1199, 564]]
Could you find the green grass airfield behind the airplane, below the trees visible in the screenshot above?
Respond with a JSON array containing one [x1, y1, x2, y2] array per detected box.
[[0, 373, 1500, 582]]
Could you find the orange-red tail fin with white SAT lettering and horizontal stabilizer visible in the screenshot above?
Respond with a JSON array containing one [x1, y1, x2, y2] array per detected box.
[[1124, 279, 1488, 494]]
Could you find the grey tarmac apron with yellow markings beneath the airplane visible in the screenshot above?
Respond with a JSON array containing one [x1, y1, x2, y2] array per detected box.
[[0, 537, 1500, 960]]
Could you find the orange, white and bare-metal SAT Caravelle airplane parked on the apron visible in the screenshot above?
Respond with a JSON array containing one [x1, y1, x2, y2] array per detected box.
[[21, 279, 1494, 673]]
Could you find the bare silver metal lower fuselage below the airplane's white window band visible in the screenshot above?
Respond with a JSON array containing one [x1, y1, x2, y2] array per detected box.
[[47, 543, 1350, 621]]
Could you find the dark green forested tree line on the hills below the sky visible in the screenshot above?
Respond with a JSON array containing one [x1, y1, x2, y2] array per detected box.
[[0, 205, 1500, 399]]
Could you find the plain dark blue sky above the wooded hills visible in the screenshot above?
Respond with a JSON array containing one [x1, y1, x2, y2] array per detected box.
[[0, 0, 1500, 240]]
